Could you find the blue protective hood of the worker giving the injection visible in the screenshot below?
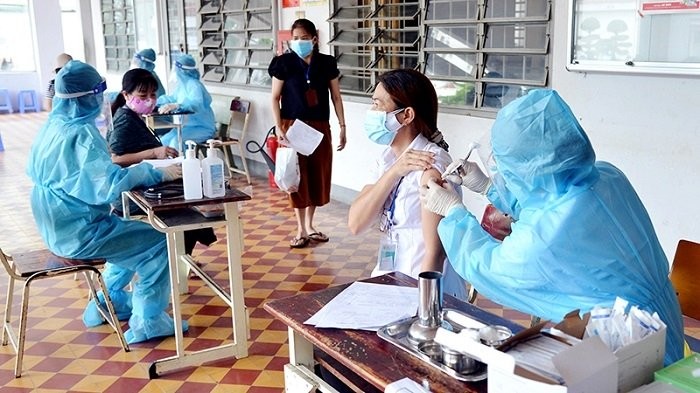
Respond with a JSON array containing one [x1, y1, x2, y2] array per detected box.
[[491, 89, 598, 204]]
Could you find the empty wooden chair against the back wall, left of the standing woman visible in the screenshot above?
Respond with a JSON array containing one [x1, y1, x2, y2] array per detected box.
[[197, 97, 252, 184]]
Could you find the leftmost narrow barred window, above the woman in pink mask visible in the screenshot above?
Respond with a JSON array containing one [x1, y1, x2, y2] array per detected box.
[[101, 0, 136, 72]]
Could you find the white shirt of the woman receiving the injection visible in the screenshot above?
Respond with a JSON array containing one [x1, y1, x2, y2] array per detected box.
[[372, 134, 467, 300]]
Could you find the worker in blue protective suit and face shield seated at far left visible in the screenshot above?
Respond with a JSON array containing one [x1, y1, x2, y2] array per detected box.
[[27, 61, 186, 343]]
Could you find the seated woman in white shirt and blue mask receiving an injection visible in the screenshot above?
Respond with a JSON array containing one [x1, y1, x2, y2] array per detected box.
[[348, 69, 467, 300]]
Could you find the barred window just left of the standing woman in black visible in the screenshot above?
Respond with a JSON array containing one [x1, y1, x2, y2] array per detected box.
[[198, 0, 274, 86]]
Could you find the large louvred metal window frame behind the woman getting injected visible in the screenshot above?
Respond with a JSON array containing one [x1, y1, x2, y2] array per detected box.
[[328, 0, 554, 117]]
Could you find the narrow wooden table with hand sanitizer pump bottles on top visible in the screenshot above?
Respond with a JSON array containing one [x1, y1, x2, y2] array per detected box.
[[122, 185, 250, 378]]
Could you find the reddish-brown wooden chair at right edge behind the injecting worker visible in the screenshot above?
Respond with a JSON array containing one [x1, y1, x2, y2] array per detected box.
[[670, 240, 700, 352]]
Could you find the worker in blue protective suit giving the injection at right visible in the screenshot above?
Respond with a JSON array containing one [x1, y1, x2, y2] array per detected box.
[[422, 89, 684, 365]]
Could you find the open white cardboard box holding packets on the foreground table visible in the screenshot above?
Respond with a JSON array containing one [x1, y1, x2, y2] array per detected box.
[[435, 311, 666, 393]]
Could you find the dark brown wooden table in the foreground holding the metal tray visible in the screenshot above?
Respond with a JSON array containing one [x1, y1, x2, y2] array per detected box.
[[264, 273, 523, 393]]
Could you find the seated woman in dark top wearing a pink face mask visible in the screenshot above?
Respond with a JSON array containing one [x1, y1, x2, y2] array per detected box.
[[107, 68, 216, 255]]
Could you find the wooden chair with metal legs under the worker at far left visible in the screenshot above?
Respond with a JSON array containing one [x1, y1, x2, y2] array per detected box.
[[0, 250, 129, 378]]
